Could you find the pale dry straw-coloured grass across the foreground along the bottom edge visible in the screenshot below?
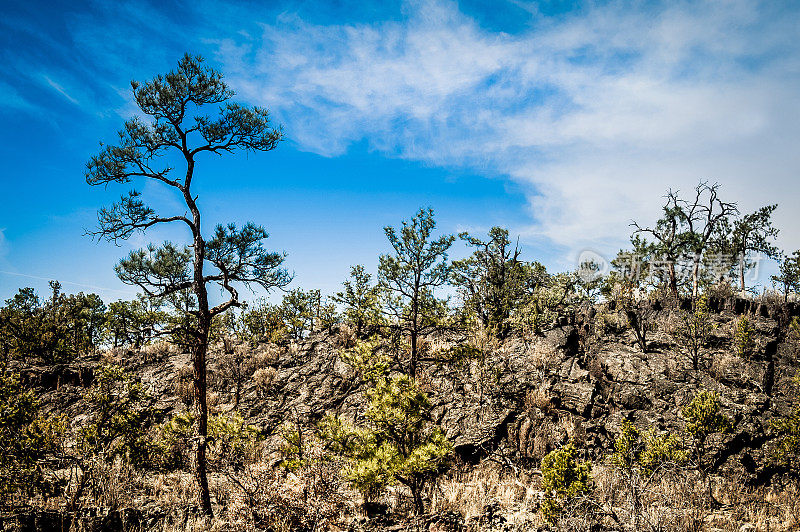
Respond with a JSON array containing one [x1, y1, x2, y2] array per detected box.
[[10, 447, 800, 532]]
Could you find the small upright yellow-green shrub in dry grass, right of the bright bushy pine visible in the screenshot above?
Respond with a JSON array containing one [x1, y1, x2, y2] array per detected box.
[[540, 443, 592, 524]]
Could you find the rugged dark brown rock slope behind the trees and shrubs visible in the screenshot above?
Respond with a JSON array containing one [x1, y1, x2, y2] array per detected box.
[[26, 299, 800, 488]]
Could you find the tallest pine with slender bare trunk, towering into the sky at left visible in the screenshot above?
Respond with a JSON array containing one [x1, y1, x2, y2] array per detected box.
[[86, 54, 290, 515]]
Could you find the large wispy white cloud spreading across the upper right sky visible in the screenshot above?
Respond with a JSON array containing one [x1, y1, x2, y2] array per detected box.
[[178, 0, 800, 264]]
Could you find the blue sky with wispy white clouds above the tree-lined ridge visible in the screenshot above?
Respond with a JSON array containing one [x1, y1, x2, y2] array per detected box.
[[0, 0, 800, 300]]
